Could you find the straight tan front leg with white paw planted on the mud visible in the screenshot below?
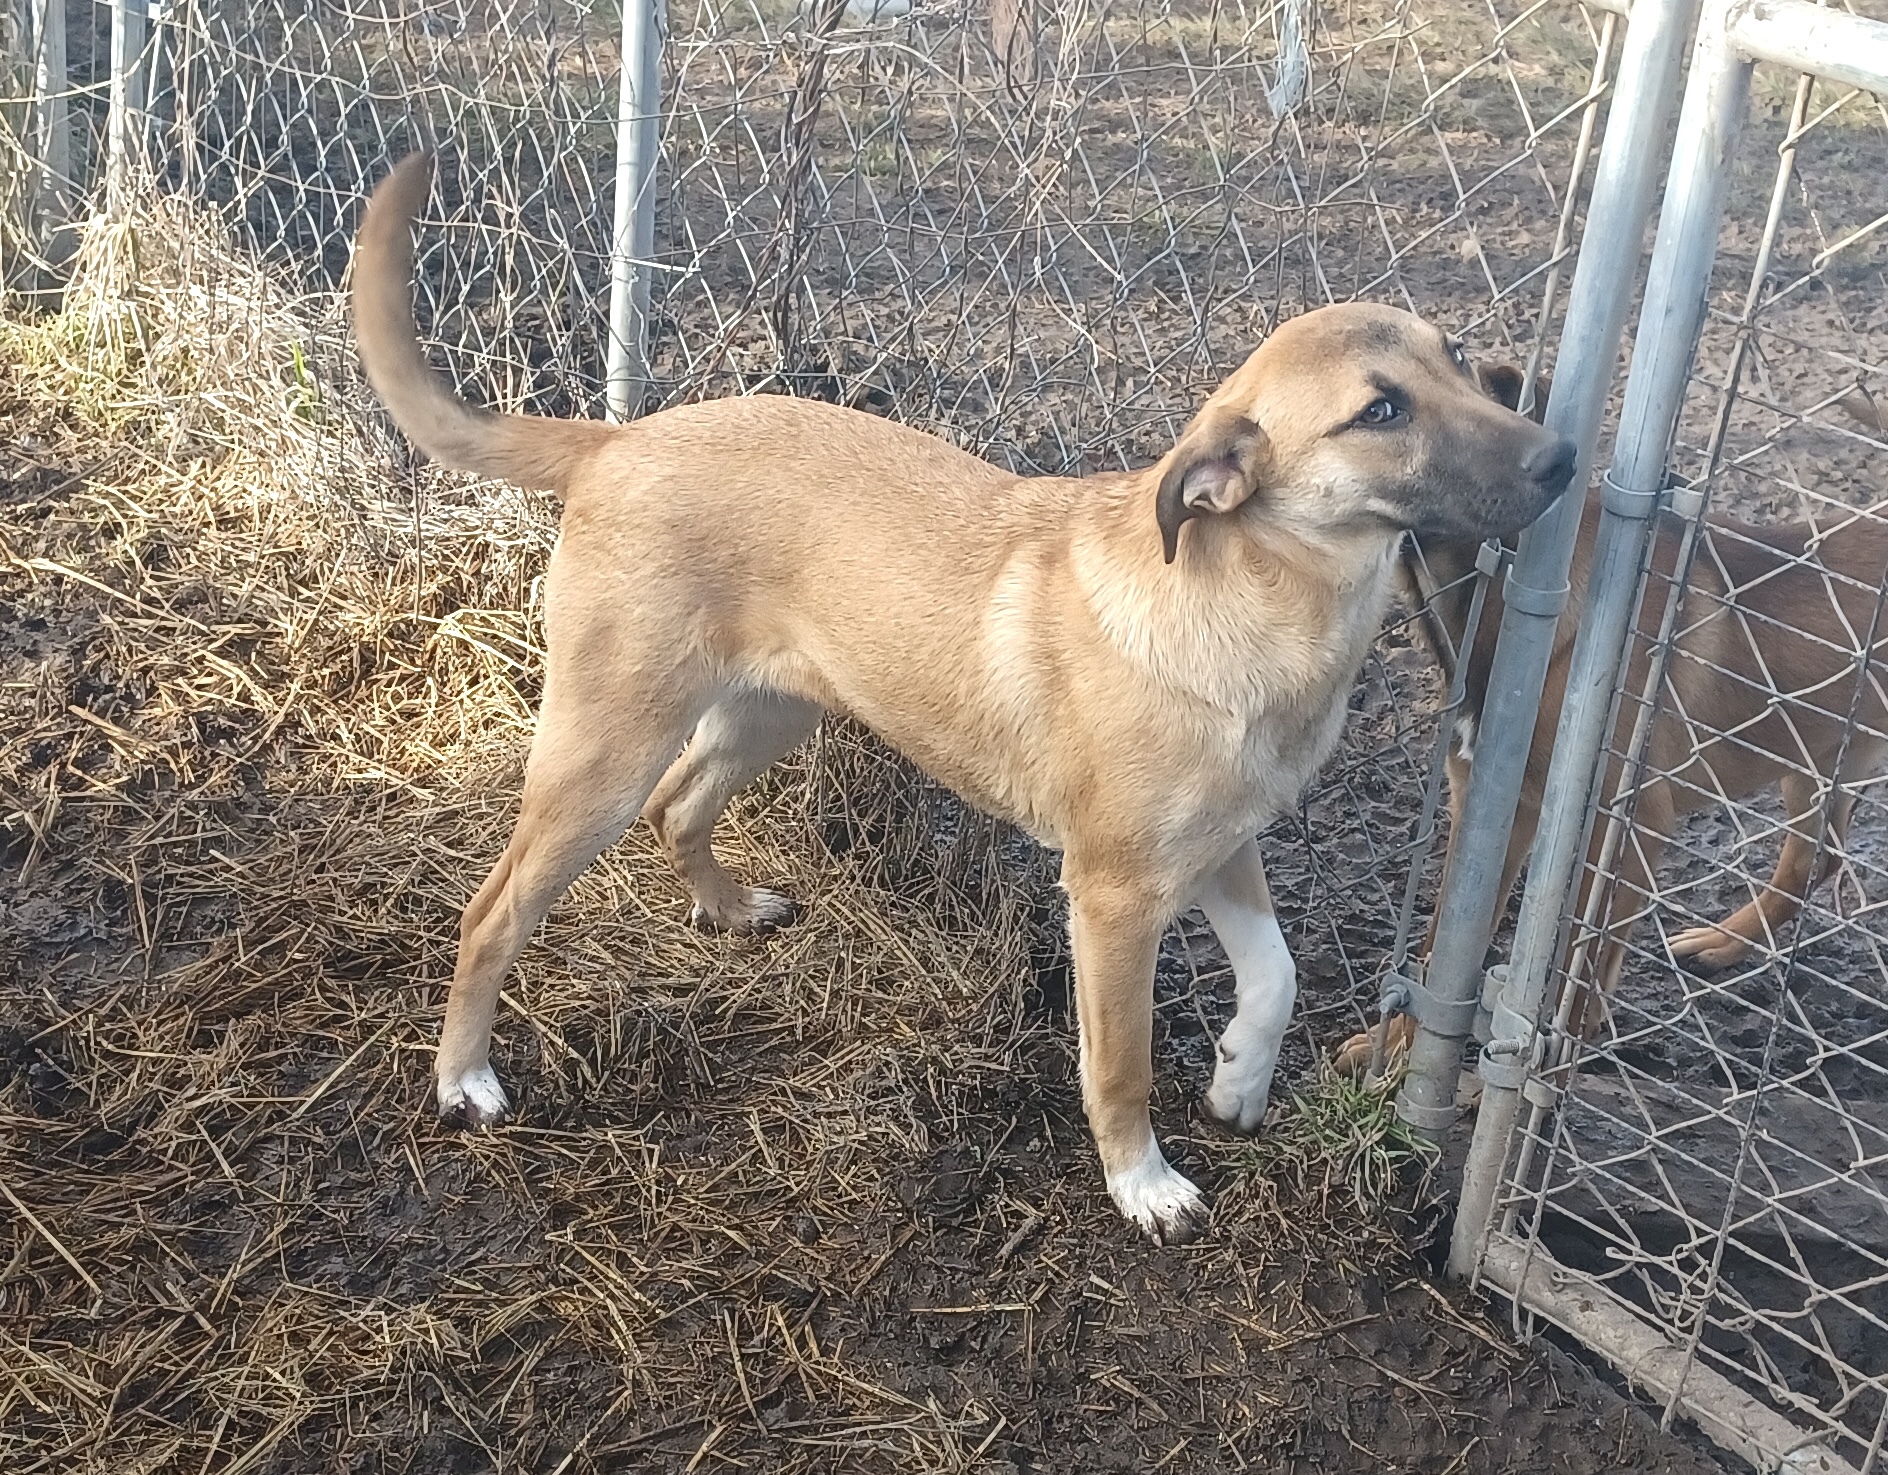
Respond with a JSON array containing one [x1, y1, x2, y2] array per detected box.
[[1063, 865, 1208, 1245]]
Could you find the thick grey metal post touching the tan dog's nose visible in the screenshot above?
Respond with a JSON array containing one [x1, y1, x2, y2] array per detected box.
[[1397, 0, 1695, 1133]]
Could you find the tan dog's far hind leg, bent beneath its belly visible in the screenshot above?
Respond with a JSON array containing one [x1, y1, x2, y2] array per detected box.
[[644, 687, 823, 933]]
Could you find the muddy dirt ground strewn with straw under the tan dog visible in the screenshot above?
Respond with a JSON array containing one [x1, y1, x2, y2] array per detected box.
[[0, 203, 1736, 1475]]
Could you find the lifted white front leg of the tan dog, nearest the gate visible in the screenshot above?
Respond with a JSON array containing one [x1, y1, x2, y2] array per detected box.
[[1199, 840, 1297, 1131]]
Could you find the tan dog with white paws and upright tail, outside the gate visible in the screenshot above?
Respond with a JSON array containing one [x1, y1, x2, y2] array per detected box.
[[353, 157, 1575, 1241]]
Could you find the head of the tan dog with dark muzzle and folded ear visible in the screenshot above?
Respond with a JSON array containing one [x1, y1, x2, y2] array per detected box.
[[1155, 302, 1575, 563]]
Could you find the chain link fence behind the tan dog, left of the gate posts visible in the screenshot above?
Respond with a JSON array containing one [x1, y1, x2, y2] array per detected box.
[[6, 0, 1620, 1065]]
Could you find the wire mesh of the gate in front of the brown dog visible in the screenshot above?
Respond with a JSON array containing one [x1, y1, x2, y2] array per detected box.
[[1497, 40, 1888, 1469]]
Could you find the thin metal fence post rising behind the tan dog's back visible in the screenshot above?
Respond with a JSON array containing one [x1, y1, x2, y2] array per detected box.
[[604, 0, 663, 421]]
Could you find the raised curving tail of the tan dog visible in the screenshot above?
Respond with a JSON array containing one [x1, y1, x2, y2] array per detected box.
[[353, 153, 614, 497]]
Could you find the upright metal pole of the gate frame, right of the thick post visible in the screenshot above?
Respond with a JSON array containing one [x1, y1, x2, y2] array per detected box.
[[1450, 0, 1750, 1275]]
